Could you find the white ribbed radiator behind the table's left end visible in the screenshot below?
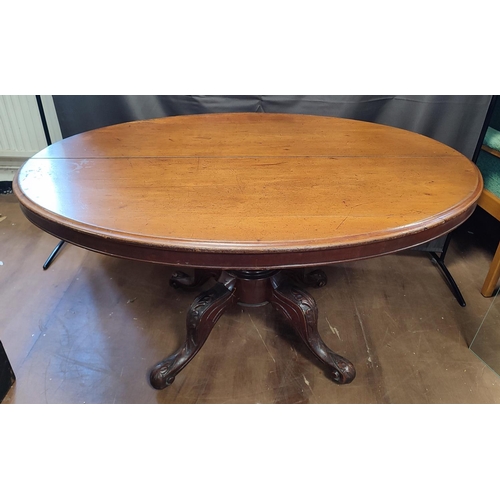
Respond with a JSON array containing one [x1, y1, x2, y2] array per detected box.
[[0, 95, 61, 181]]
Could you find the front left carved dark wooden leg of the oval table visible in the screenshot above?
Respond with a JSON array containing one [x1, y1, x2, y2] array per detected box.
[[150, 273, 236, 389]]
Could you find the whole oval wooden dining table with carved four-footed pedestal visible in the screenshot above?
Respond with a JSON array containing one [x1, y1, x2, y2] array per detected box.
[[14, 113, 483, 389]]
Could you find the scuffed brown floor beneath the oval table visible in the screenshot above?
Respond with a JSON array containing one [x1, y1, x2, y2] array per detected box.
[[0, 195, 500, 404]]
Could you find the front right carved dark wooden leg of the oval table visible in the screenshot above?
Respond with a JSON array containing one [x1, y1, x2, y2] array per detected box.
[[270, 273, 356, 384]]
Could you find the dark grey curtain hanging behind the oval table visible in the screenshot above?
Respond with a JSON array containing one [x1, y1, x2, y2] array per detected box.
[[53, 95, 492, 158]]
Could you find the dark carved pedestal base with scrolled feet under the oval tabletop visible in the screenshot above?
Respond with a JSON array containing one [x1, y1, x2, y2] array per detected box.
[[150, 270, 356, 389]]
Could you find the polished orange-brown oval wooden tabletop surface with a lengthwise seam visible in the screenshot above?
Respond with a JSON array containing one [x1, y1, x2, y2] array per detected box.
[[15, 113, 482, 258]]
